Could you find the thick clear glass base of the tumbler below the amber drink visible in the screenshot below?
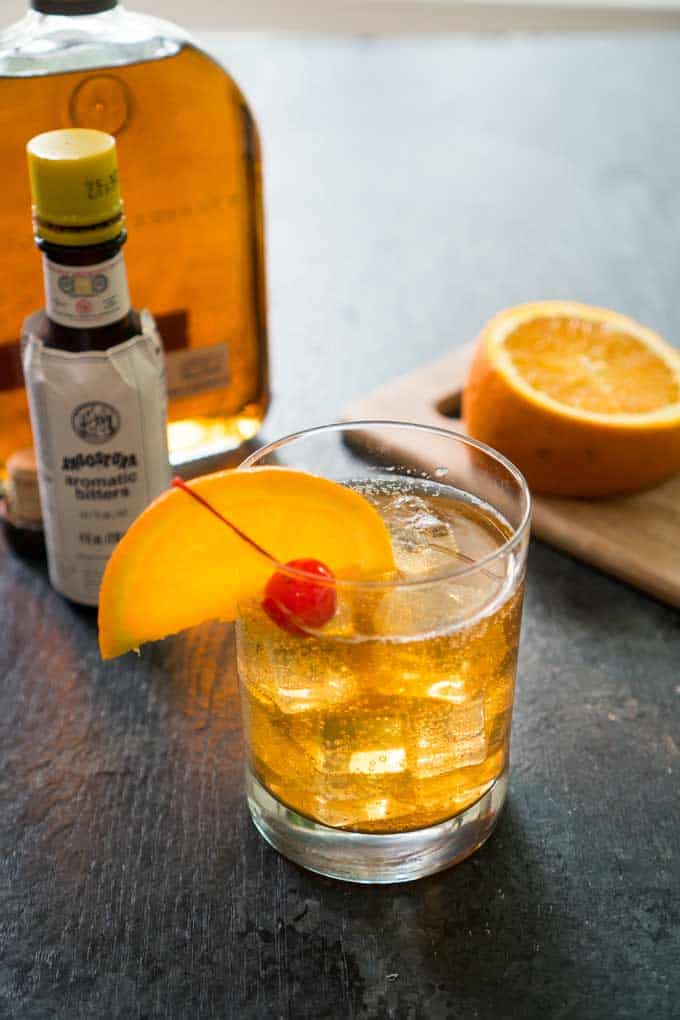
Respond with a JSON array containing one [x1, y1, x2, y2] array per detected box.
[[246, 769, 508, 884]]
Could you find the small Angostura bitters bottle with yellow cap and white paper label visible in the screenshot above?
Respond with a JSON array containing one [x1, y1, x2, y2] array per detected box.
[[22, 129, 170, 606]]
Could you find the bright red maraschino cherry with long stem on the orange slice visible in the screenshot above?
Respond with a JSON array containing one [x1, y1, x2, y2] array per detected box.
[[172, 478, 337, 638]]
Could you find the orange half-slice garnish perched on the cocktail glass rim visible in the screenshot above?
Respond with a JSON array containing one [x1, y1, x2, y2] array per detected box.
[[99, 467, 395, 659]]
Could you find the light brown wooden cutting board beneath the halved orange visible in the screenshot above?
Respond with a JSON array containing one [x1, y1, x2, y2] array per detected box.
[[345, 345, 680, 607]]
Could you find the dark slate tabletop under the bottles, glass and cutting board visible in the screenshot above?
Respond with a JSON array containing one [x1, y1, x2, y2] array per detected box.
[[0, 27, 680, 1020]]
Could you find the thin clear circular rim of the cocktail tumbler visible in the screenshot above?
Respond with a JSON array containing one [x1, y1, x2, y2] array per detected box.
[[236, 418, 531, 591]]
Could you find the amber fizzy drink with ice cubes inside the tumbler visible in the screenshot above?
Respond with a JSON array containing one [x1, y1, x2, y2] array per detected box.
[[238, 479, 522, 832]]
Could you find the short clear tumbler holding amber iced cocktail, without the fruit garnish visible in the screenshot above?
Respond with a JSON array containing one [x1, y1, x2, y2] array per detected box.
[[237, 422, 530, 882]]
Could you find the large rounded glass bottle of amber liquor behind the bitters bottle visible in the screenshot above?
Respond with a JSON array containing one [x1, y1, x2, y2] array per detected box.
[[0, 0, 269, 479]]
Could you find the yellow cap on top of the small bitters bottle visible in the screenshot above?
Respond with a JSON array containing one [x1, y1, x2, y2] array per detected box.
[[27, 128, 123, 246]]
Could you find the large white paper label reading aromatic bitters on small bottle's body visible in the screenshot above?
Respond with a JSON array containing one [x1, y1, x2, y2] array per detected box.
[[23, 314, 170, 606]]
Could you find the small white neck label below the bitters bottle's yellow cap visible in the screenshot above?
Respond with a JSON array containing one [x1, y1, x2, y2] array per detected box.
[[43, 252, 130, 329]]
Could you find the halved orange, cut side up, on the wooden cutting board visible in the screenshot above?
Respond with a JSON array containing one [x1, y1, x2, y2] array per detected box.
[[463, 301, 680, 497]]
